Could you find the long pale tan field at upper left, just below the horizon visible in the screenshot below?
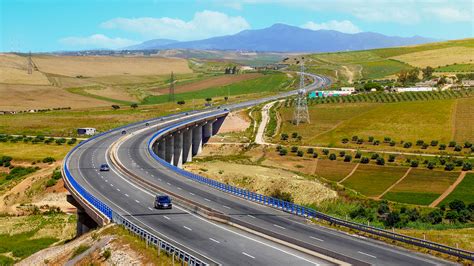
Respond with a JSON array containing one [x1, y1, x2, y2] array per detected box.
[[33, 56, 192, 77]]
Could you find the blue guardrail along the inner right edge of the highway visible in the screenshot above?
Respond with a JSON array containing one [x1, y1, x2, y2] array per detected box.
[[148, 118, 474, 261]]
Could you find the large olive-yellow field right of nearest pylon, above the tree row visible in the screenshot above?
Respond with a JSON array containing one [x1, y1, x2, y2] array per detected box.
[[282, 100, 460, 148]]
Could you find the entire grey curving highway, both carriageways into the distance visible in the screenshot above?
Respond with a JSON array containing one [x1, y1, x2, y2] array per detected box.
[[67, 72, 454, 265]]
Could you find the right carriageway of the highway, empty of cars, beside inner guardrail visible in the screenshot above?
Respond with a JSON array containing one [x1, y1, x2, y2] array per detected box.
[[113, 112, 454, 266]]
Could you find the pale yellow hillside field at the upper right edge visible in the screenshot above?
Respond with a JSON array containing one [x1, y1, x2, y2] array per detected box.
[[392, 47, 474, 67]]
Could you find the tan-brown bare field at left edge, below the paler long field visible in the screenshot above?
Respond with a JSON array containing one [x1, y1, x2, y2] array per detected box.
[[0, 84, 110, 110]]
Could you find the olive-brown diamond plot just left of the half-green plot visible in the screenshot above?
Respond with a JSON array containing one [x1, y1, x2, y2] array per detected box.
[[342, 165, 407, 197]]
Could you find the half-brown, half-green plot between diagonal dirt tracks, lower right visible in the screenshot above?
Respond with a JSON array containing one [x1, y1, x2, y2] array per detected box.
[[383, 169, 459, 205]]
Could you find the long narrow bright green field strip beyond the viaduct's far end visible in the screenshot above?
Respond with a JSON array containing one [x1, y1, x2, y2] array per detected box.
[[143, 73, 293, 104]]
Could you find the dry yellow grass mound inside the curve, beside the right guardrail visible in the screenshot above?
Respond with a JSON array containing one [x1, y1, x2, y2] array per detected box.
[[185, 161, 337, 204]]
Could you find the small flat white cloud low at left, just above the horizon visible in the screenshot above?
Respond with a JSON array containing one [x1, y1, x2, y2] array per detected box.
[[59, 34, 138, 49]]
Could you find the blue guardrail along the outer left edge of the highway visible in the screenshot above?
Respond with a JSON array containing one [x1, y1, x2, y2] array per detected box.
[[63, 110, 208, 266]]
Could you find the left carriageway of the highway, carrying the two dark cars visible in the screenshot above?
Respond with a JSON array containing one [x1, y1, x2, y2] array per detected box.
[[69, 113, 331, 265]]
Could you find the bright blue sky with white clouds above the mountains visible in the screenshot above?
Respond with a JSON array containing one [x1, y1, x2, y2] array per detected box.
[[0, 0, 474, 52]]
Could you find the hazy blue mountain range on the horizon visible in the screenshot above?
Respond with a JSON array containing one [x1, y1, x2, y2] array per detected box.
[[129, 24, 435, 52]]
